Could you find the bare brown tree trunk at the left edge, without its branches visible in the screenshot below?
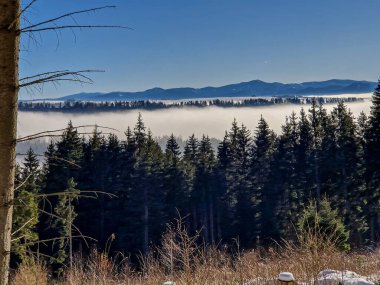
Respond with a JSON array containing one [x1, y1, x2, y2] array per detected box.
[[0, 0, 20, 285]]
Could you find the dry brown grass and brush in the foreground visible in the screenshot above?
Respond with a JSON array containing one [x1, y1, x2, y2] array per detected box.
[[12, 225, 380, 285]]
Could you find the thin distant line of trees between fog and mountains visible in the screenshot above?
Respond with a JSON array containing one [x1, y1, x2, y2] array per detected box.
[[18, 96, 363, 112]]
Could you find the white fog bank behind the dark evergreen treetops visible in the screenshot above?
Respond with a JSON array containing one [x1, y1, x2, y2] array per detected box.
[[18, 94, 371, 139]]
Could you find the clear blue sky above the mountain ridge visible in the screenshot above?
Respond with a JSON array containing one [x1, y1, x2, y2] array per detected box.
[[20, 0, 380, 98]]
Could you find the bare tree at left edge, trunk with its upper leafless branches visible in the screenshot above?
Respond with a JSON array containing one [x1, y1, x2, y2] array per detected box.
[[0, 0, 128, 285]]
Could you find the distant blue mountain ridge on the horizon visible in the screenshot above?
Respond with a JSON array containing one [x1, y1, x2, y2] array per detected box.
[[38, 79, 377, 101]]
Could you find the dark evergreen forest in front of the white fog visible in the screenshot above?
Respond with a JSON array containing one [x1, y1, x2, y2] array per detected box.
[[12, 83, 380, 270]]
